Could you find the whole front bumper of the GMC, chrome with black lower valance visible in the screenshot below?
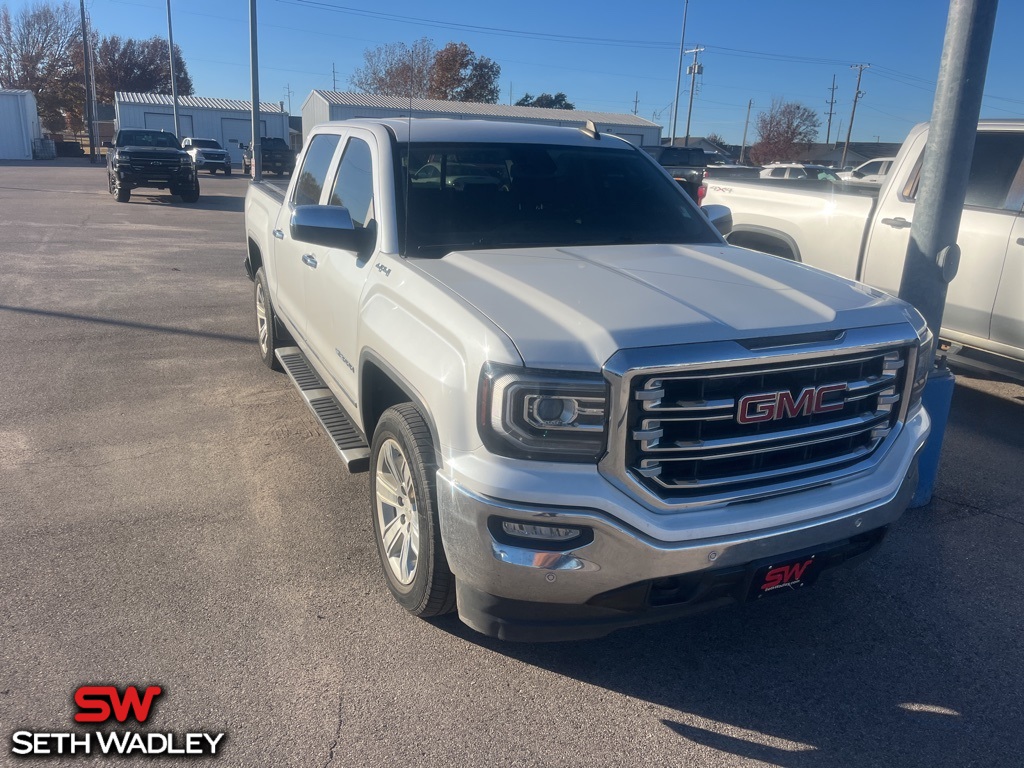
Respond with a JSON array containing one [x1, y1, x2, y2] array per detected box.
[[437, 412, 929, 641]]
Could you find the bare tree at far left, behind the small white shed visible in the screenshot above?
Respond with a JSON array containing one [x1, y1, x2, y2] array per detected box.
[[0, 0, 79, 130]]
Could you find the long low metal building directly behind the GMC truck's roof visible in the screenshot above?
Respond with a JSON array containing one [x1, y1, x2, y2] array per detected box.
[[302, 90, 662, 146]]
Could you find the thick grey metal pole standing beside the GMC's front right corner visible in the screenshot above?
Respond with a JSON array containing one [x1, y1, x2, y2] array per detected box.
[[899, 0, 997, 346]]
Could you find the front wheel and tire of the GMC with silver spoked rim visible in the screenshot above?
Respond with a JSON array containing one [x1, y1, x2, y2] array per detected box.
[[370, 402, 455, 618]]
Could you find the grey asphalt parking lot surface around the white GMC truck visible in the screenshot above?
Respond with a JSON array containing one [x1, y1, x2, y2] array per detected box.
[[0, 161, 1024, 768]]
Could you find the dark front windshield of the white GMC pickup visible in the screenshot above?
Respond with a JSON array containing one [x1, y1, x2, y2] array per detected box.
[[396, 143, 720, 256]]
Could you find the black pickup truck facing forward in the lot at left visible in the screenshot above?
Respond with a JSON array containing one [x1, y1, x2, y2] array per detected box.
[[103, 128, 199, 203]]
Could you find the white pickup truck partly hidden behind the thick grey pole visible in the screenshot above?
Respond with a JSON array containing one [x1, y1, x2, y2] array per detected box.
[[703, 120, 1024, 377]]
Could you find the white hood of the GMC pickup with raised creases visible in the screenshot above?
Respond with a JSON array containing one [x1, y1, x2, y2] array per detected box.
[[413, 245, 909, 371]]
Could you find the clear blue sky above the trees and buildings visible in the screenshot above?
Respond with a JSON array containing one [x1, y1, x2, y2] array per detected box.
[[22, 0, 1024, 143]]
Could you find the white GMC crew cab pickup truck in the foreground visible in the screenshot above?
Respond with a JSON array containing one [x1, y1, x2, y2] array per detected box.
[[245, 120, 932, 640]]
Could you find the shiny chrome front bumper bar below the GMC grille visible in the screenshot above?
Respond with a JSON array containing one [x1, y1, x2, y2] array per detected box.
[[437, 409, 928, 640]]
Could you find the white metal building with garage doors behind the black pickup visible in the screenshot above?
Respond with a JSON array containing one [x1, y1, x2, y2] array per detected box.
[[114, 91, 288, 164]]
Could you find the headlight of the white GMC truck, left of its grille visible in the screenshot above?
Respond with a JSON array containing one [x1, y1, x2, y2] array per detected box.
[[477, 362, 608, 463]]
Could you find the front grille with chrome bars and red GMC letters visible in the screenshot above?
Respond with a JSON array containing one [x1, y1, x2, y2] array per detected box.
[[624, 345, 911, 501]]
